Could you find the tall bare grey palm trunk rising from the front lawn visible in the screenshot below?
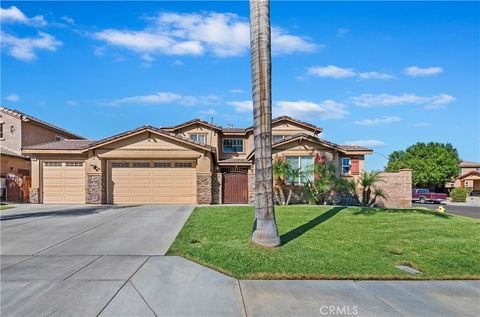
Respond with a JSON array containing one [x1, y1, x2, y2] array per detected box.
[[250, 0, 280, 247]]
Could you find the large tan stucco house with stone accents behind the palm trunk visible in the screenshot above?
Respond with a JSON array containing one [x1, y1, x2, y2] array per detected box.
[[23, 116, 372, 204]]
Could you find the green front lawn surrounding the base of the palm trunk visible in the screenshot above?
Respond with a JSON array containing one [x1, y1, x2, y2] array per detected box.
[[167, 206, 480, 279]]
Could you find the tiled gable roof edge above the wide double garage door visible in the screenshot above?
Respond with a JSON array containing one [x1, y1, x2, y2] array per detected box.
[[79, 125, 215, 152]]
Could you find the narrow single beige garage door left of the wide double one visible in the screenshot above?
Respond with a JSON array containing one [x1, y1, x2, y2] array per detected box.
[[43, 161, 85, 204]]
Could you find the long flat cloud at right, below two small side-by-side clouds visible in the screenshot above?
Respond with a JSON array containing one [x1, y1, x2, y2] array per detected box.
[[351, 94, 455, 110]]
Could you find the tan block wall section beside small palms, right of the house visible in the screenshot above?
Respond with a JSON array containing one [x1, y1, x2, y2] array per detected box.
[[377, 169, 412, 208]]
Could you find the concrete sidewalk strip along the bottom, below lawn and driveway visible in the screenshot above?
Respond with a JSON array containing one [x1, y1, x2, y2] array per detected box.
[[1, 255, 480, 317]]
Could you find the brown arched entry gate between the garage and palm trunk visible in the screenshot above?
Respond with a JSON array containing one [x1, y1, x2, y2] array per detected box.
[[223, 168, 248, 204]]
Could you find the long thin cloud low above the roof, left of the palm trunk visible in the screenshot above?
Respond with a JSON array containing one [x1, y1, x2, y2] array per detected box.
[[103, 92, 221, 106]]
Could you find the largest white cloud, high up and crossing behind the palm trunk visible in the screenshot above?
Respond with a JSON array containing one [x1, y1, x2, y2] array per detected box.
[[93, 12, 318, 57]]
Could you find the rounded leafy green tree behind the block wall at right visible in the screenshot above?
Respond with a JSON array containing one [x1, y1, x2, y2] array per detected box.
[[385, 142, 460, 188]]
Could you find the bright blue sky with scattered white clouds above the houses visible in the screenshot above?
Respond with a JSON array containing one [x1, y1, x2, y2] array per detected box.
[[1, 1, 480, 169]]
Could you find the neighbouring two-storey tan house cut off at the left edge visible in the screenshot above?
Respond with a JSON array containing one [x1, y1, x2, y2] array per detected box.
[[0, 107, 82, 200]]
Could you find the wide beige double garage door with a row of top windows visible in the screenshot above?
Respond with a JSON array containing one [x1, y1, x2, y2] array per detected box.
[[109, 161, 197, 204]]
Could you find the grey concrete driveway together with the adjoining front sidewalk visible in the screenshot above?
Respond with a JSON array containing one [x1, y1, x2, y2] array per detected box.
[[0, 205, 480, 317]]
